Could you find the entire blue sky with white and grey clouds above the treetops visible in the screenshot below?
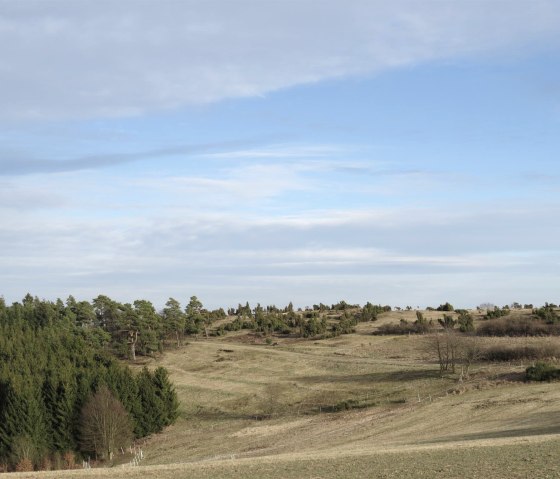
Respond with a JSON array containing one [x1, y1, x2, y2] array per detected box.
[[0, 0, 560, 308]]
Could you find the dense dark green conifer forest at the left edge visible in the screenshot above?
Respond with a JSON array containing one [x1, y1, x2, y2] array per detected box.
[[0, 295, 178, 470]]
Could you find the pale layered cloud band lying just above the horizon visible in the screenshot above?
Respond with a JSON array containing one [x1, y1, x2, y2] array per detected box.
[[0, 198, 560, 306]]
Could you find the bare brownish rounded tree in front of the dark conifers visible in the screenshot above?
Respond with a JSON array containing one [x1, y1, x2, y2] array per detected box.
[[80, 386, 133, 460]]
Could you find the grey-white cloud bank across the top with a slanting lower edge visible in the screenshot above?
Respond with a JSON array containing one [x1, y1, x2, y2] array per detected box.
[[0, 0, 560, 120]]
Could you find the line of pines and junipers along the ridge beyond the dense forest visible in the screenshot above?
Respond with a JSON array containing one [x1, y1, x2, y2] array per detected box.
[[14, 295, 391, 361]]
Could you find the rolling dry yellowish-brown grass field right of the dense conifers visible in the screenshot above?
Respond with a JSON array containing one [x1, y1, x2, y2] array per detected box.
[[8, 311, 560, 479]]
